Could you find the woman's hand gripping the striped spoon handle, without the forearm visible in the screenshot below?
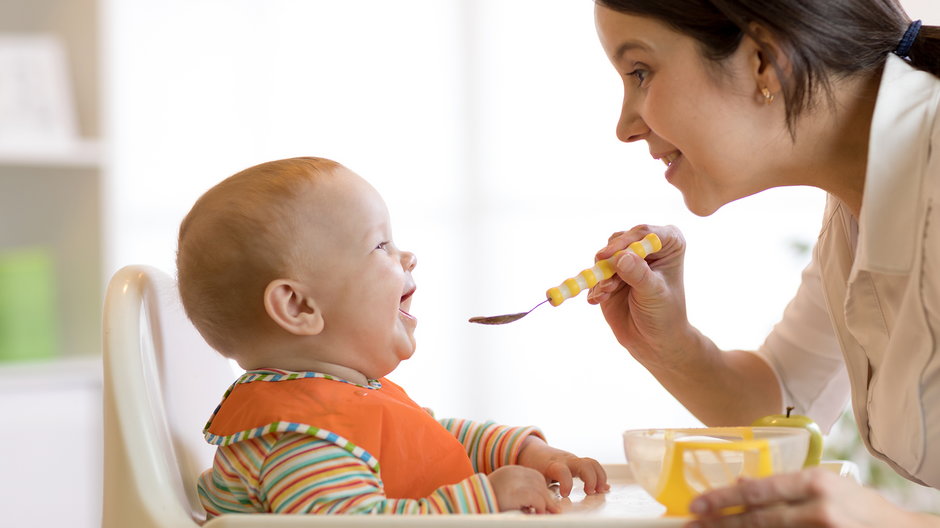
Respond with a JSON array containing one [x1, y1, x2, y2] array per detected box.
[[588, 225, 698, 369]]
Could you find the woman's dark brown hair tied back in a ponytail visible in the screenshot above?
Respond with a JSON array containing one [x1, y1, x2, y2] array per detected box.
[[595, 0, 940, 132]]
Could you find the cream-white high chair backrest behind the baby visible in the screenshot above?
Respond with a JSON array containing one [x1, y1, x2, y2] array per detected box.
[[102, 266, 235, 528]]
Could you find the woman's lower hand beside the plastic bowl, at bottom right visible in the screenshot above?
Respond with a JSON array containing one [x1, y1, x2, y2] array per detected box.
[[686, 468, 940, 528]]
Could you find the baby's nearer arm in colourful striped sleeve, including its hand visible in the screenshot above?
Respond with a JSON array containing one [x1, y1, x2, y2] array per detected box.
[[218, 434, 558, 517]]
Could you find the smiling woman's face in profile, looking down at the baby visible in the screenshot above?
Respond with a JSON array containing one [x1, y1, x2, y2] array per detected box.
[[595, 5, 789, 216]]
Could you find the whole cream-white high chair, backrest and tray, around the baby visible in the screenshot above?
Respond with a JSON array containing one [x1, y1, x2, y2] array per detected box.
[[102, 266, 683, 528]]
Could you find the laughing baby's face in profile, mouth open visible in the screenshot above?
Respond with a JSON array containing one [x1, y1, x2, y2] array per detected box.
[[297, 168, 417, 378]]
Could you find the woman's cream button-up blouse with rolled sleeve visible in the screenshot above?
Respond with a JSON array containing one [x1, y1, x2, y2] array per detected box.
[[757, 55, 940, 488]]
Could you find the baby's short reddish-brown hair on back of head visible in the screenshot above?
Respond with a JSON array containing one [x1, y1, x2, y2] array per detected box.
[[176, 157, 341, 357]]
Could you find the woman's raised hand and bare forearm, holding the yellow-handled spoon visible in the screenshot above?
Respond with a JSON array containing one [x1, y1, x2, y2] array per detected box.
[[588, 225, 781, 426]]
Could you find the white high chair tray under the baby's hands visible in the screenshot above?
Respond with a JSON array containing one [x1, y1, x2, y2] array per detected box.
[[203, 464, 688, 528]]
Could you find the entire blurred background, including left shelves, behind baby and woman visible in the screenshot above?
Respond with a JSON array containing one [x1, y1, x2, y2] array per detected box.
[[0, 0, 940, 527]]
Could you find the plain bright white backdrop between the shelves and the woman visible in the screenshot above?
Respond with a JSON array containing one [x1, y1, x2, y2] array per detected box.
[[104, 0, 932, 462]]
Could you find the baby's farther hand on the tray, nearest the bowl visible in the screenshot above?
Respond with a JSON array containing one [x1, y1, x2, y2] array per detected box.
[[517, 436, 610, 497]]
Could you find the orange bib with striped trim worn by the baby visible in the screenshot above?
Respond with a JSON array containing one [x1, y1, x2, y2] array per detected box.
[[205, 371, 473, 499]]
